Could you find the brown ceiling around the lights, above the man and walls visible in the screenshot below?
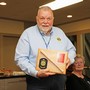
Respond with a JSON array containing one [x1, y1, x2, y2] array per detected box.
[[0, 0, 90, 25]]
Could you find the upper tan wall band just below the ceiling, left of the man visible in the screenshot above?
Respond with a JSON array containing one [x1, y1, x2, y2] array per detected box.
[[0, 19, 24, 34]]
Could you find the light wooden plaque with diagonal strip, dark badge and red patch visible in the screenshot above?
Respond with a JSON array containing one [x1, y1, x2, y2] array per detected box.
[[36, 49, 68, 74]]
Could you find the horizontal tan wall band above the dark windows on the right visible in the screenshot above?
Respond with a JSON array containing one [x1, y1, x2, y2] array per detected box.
[[59, 19, 90, 33]]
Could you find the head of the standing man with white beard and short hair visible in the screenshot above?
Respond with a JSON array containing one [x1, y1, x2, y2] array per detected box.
[[36, 6, 54, 33]]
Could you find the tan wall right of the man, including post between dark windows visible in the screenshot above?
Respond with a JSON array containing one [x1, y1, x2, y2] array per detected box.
[[58, 19, 90, 55]]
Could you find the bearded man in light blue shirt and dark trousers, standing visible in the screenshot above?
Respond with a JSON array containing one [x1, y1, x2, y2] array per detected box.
[[15, 6, 76, 90]]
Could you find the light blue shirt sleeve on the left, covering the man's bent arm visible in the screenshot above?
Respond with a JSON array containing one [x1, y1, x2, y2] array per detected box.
[[15, 32, 38, 77]]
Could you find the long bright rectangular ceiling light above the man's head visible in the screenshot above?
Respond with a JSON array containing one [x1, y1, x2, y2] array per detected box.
[[40, 0, 83, 10]]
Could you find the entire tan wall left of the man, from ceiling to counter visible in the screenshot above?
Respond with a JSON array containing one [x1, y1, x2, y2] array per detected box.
[[0, 19, 24, 70]]
